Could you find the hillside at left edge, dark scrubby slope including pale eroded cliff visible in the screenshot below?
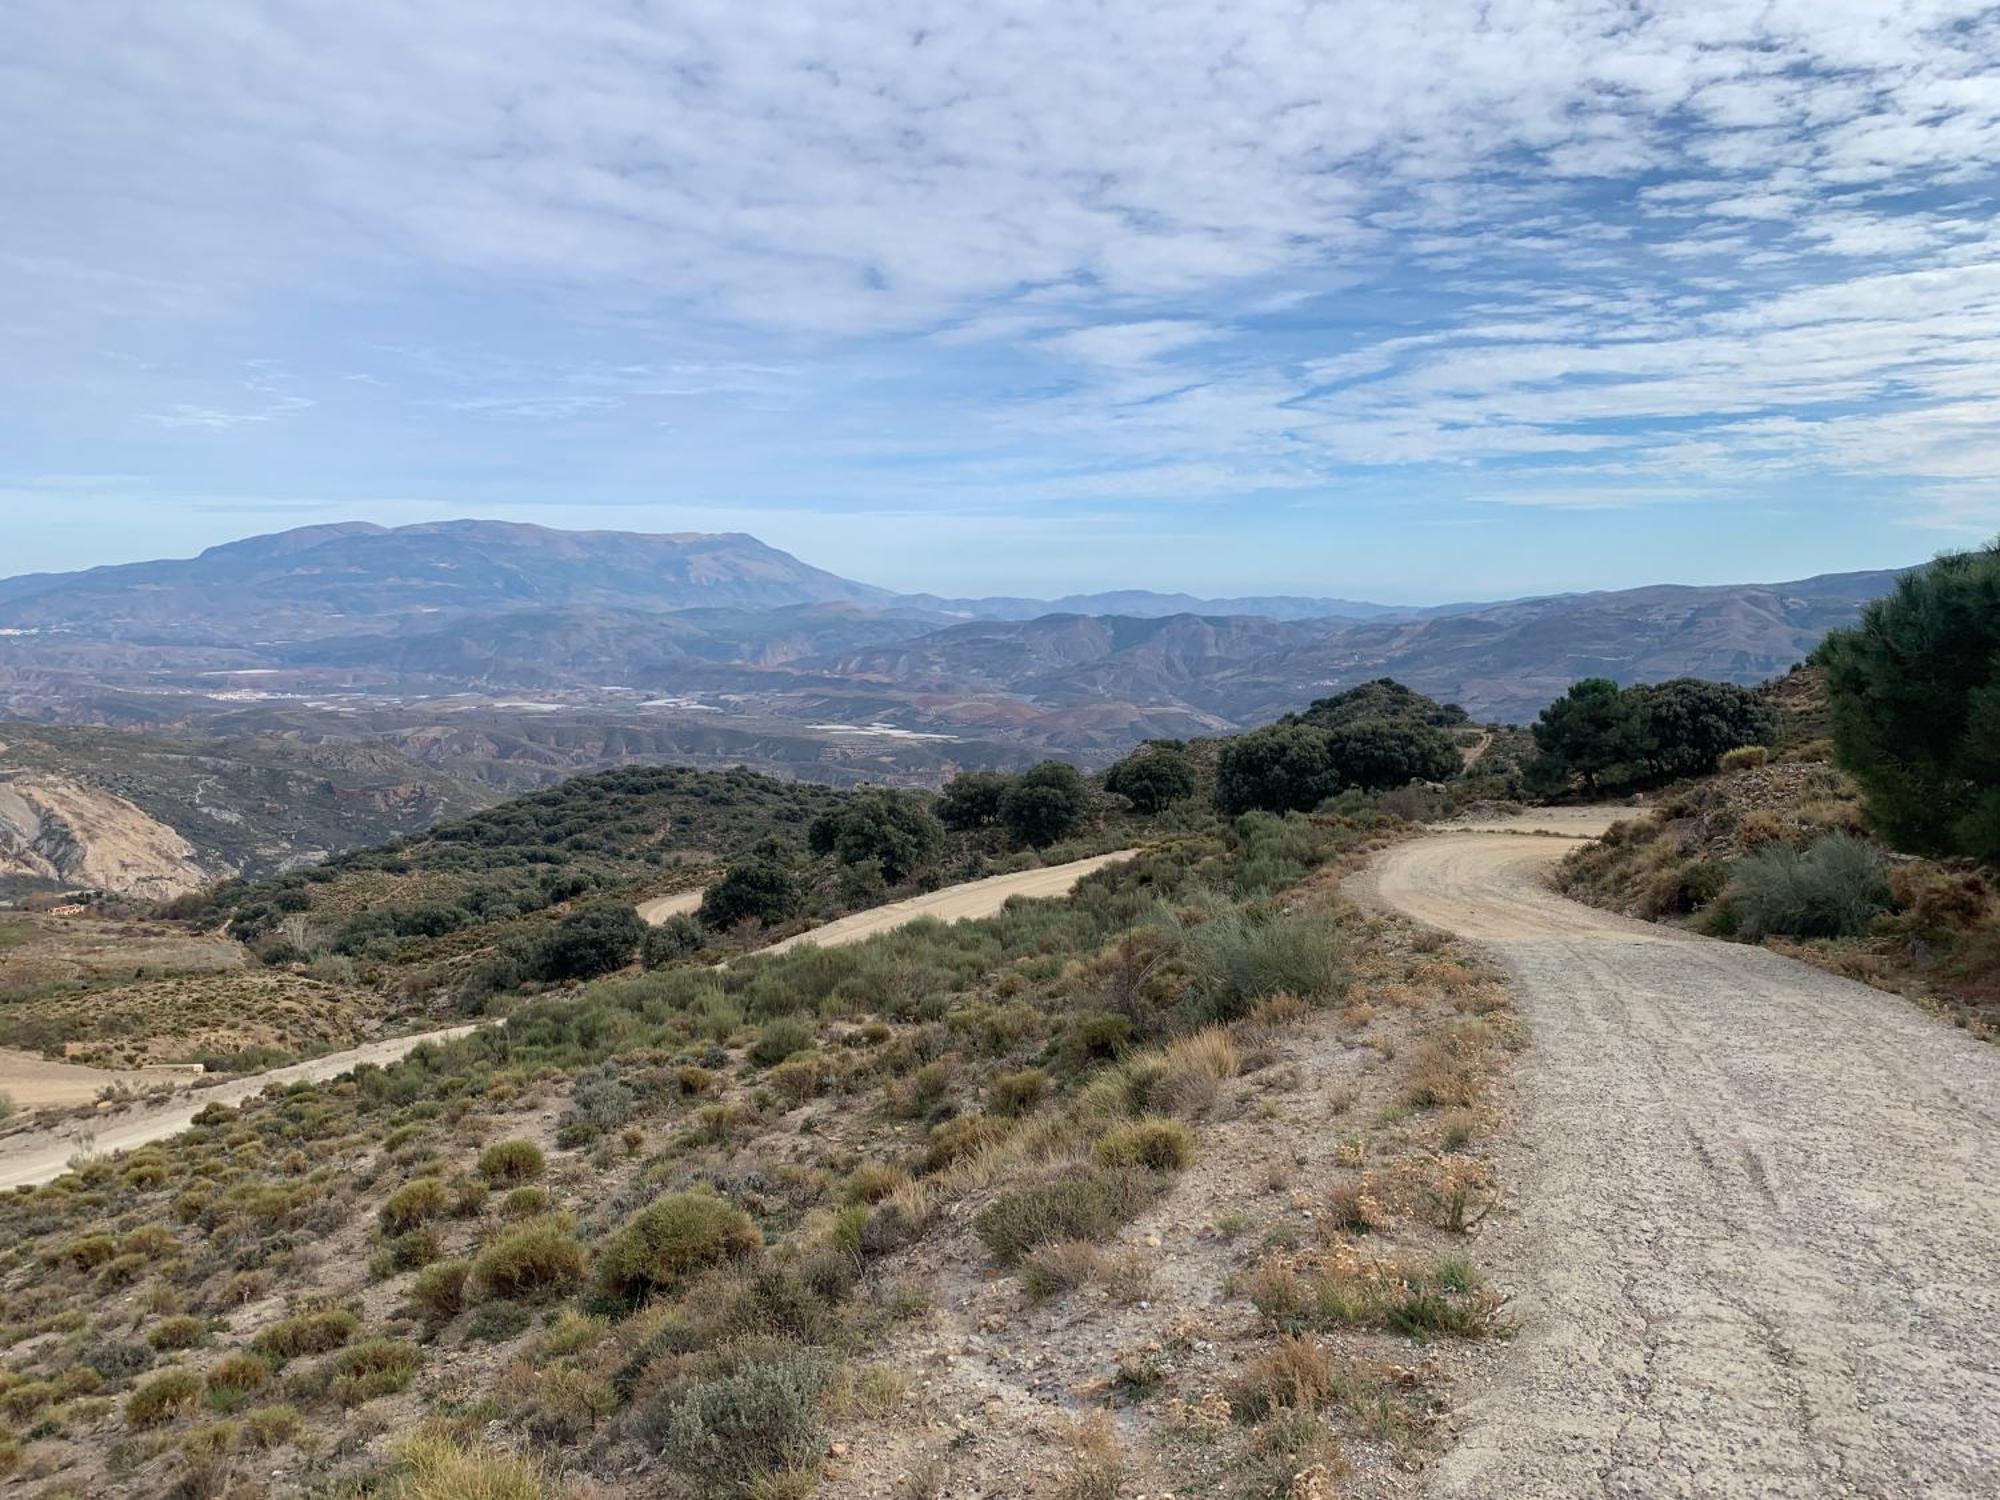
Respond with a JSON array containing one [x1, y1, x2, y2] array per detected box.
[[0, 722, 494, 898]]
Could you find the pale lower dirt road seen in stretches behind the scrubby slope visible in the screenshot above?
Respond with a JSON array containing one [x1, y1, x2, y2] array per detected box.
[[0, 850, 1136, 1192]]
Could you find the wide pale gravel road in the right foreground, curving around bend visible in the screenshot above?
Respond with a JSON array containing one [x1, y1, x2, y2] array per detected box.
[[1362, 812, 2000, 1500]]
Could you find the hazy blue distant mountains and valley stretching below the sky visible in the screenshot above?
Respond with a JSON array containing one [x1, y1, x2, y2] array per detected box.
[[0, 520, 1896, 780]]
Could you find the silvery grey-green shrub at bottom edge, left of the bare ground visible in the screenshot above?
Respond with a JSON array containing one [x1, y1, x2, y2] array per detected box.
[[640, 1340, 834, 1496]]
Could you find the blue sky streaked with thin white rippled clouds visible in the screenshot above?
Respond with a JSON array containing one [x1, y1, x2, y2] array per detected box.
[[0, 0, 2000, 602]]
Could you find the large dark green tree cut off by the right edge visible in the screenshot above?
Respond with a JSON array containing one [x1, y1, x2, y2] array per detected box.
[[1814, 540, 2000, 864]]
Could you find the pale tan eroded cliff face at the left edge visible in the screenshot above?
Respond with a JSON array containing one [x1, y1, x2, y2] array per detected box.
[[0, 772, 212, 898]]
